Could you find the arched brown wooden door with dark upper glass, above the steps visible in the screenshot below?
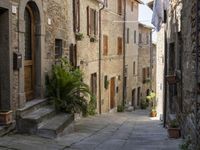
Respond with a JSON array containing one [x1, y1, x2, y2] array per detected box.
[[24, 6, 35, 101]]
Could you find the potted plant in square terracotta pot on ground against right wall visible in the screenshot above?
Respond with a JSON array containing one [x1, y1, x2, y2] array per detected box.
[[168, 119, 180, 138]]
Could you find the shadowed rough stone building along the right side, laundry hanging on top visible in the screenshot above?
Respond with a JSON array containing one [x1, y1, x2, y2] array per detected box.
[[166, 0, 200, 149]]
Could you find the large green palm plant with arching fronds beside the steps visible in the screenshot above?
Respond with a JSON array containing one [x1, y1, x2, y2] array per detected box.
[[46, 58, 93, 115]]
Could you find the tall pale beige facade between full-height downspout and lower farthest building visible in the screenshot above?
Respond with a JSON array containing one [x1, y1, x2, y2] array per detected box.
[[125, 0, 141, 106]]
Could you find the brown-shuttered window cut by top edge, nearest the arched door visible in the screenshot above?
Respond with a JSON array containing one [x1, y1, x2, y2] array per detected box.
[[73, 0, 80, 32]]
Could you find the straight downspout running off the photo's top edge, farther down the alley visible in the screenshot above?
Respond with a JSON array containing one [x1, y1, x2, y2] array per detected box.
[[122, 0, 126, 106]]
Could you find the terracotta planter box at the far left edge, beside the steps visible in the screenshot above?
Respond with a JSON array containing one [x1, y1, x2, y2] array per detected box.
[[0, 111, 12, 125]]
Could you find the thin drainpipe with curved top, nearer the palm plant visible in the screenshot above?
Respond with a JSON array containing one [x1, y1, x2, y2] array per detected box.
[[99, 4, 105, 114]]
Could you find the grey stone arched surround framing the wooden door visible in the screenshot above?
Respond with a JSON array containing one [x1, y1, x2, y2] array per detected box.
[[19, 0, 45, 107]]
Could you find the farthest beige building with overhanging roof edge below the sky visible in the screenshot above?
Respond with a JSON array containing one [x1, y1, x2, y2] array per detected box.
[[137, 23, 152, 106]]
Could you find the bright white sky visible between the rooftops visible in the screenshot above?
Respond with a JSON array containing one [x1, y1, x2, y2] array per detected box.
[[139, 0, 157, 42]]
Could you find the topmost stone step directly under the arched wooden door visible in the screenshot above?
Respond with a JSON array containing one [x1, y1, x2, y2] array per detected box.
[[16, 99, 48, 118]]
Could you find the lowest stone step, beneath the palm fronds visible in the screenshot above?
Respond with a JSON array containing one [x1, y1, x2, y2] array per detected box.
[[37, 113, 74, 138]]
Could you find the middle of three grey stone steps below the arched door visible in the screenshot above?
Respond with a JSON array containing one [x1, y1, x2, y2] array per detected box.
[[17, 106, 56, 134]]
